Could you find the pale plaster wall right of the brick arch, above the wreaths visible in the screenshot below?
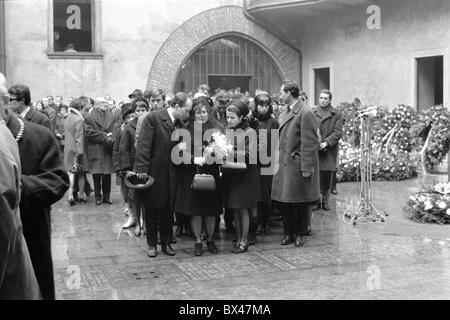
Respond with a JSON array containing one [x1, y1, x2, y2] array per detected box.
[[296, 0, 450, 107]]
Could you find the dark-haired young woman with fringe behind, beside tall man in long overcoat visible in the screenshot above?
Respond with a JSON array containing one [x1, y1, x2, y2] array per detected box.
[[253, 93, 279, 235]]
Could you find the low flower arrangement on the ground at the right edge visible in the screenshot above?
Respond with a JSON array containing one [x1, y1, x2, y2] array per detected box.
[[404, 182, 450, 224]]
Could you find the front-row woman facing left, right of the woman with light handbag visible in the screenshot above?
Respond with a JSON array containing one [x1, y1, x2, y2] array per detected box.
[[223, 100, 259, 253]]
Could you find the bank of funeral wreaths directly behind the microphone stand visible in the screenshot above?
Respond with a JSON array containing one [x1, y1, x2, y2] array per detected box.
[[337, 103, 420, 182]]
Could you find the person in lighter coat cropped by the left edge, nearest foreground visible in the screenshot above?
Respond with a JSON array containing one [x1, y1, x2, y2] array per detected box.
[[0, 73, 41, 300]]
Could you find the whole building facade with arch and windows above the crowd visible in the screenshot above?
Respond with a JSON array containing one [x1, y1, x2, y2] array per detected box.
[[0, 0, 450, 108]]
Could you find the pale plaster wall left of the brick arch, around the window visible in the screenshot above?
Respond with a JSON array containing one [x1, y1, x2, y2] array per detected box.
[[5, 0, 246, 100]]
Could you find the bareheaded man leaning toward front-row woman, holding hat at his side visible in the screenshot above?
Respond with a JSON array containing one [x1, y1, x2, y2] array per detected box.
[[134, 92, 192, 257]]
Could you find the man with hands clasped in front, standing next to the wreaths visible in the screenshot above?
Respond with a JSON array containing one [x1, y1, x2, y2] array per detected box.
[[313, 89, 344, 211]]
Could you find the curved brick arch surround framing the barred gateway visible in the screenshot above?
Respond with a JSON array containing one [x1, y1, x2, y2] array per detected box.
[[147, 6, 300, 92]]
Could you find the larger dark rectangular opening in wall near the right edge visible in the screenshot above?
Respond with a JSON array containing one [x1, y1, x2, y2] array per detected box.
[[416, 56, 444, 110]]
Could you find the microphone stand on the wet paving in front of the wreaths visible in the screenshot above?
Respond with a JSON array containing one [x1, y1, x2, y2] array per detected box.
[[343, 107, 388, 225]]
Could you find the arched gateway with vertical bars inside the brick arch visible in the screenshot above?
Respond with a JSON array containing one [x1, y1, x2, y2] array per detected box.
[[174, 35, 281, 95]]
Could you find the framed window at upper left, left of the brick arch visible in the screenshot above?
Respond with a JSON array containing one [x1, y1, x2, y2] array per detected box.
[[48, 0, 102, 59]]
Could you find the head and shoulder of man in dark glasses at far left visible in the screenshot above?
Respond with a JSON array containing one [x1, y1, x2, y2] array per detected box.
[[8, 84, 52, 130]]
